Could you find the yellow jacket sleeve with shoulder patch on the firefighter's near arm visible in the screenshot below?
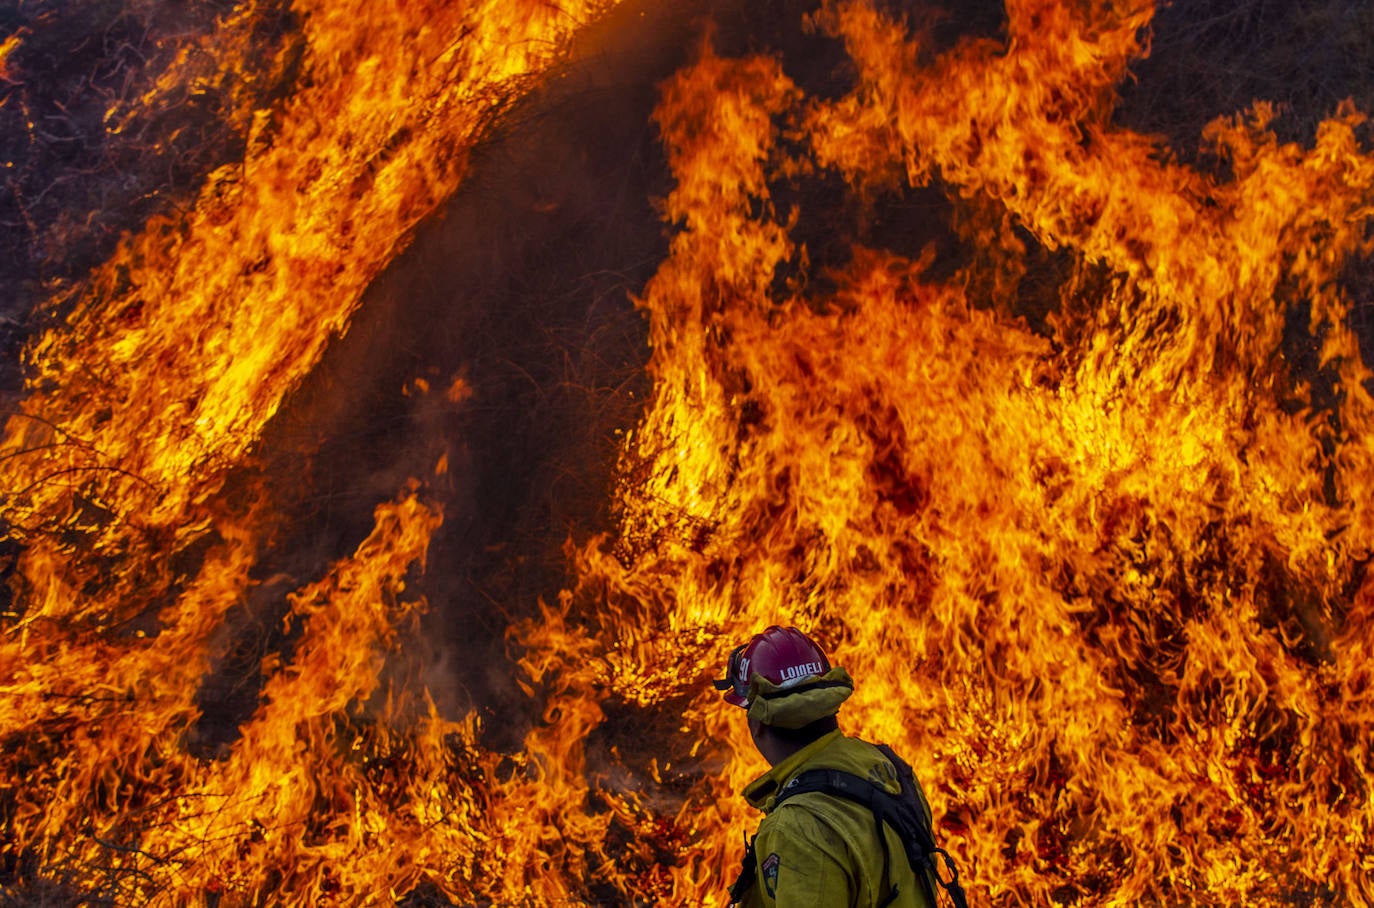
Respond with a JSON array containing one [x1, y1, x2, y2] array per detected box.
[[754, 806, 856, 908]]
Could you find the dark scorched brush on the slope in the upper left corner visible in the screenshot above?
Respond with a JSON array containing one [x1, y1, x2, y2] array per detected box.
[[0, 0, 300, 379]]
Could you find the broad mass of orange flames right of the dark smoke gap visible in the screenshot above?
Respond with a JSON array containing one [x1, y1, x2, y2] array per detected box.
[[516, 0, 1374, 904]]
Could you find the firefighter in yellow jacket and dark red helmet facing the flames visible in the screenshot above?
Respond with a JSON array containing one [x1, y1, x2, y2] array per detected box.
[[714, 625, 937, 908]]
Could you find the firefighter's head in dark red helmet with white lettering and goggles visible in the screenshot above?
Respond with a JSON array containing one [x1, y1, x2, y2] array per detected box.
[[714, 625, 853, 762]]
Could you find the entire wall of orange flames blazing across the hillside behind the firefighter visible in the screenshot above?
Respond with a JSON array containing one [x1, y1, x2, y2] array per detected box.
[[0, 0, 1374, 905]]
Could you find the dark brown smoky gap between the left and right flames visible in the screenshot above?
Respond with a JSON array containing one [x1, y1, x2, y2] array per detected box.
[[217, 4, 741, 749]]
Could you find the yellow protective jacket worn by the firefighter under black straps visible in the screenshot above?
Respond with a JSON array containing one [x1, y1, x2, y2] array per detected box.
[[739, 731, 934, 908]]
